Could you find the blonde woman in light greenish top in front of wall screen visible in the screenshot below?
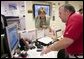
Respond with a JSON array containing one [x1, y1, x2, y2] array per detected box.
[[35, 7, 50, 29]]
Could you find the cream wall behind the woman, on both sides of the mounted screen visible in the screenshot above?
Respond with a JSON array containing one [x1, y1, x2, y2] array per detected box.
[[26, 1, 64, 30]]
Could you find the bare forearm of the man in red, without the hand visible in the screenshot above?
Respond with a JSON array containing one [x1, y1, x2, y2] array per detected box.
[[49, 37, 74, 51]]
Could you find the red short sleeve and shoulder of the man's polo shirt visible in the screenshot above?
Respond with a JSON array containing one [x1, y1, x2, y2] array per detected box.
[[63, 16, 83, 40]]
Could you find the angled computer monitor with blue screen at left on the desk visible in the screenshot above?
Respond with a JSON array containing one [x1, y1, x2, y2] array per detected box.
[[6, 23, 19, 57]]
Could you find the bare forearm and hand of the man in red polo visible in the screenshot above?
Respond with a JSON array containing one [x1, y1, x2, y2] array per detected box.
[[41, 37, 74, 54]]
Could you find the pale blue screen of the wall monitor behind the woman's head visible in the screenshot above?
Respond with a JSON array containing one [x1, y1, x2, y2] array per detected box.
[[33, 4, 50, 17]]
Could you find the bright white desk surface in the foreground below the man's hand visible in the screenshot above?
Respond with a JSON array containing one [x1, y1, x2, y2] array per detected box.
[[27, 48, 58, 58]]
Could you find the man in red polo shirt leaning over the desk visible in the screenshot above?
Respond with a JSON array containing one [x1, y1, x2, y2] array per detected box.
[[41, 4, 83, 58]]
